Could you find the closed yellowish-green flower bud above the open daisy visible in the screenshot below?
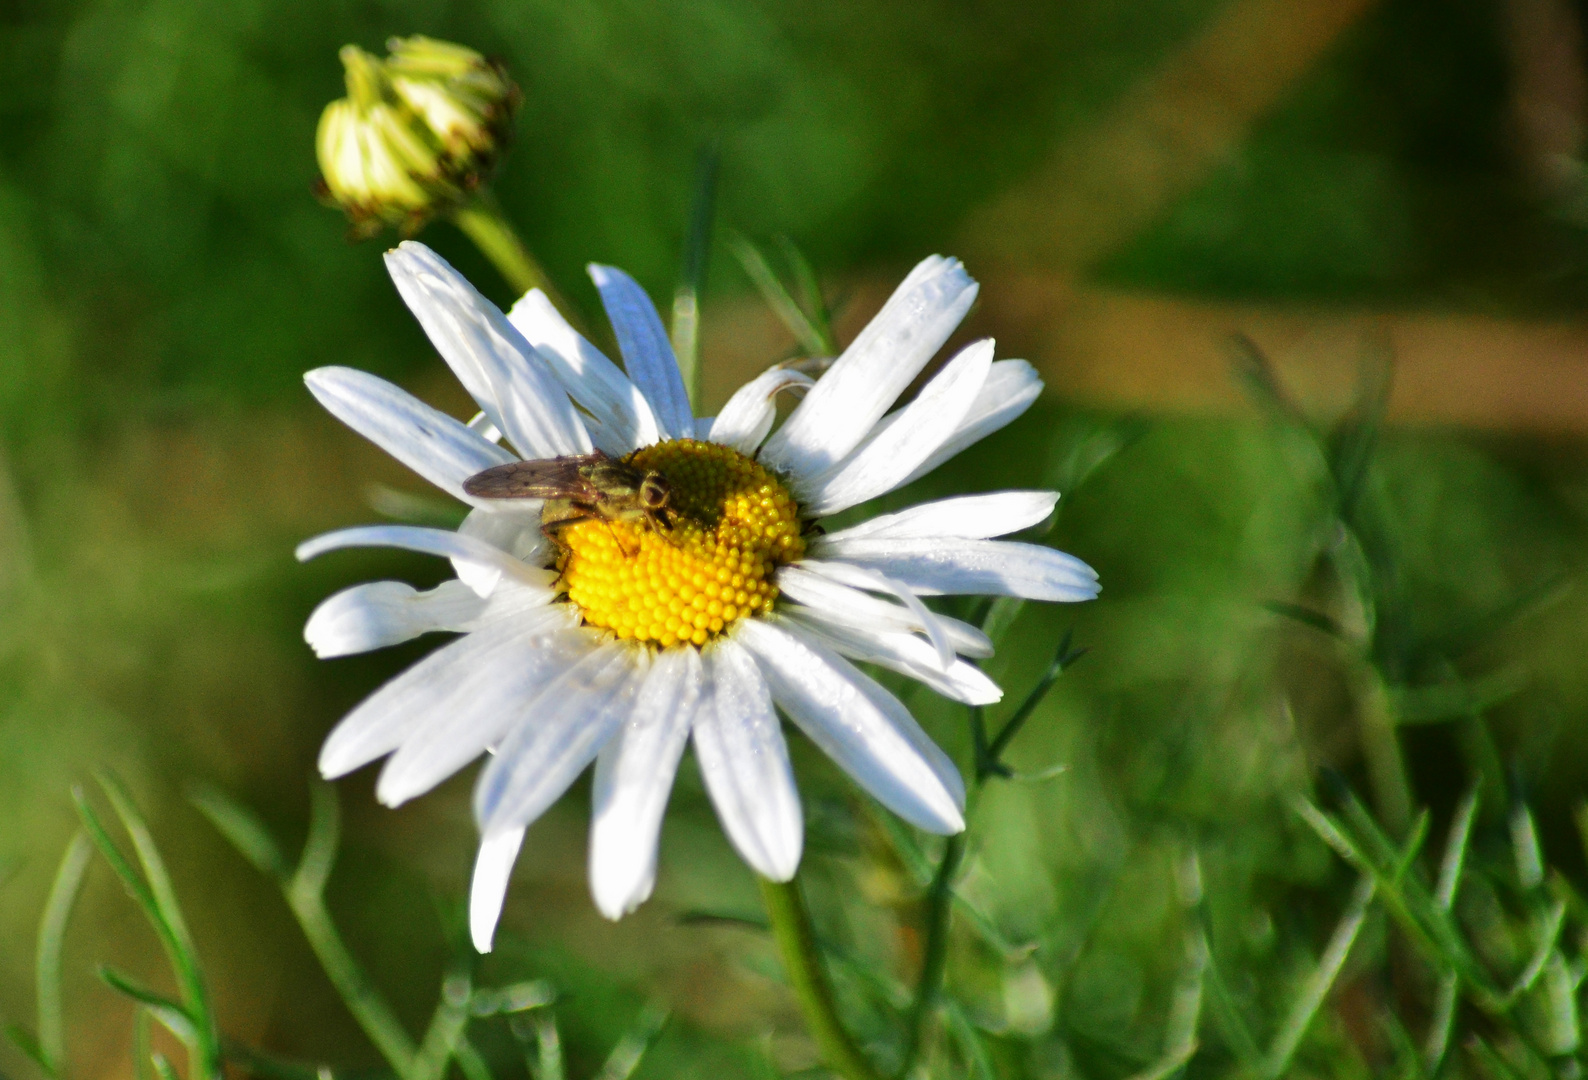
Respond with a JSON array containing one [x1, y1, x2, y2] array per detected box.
[[314, 37, 519, 238]]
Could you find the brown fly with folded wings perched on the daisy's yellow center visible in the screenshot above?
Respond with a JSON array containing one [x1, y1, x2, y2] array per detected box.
[[464, 451, 672, 546]]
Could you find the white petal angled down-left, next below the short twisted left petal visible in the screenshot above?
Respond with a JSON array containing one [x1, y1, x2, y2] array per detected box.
[[319, 604, 578, 780]]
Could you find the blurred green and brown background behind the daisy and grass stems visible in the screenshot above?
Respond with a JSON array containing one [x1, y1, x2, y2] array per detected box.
[[9, 0, 1588, 1080]]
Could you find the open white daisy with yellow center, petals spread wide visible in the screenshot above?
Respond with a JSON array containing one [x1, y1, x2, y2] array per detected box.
[[299, 241, 1097, 951]]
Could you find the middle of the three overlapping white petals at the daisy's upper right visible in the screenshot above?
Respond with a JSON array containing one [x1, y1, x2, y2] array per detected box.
[[796, 338, 993, 516]]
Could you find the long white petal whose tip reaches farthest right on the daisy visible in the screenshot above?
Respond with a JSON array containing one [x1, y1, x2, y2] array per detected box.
[[813, 538, 1097, 600]]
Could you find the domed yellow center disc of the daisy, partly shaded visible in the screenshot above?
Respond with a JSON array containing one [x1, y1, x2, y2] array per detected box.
[[557, 438, 805, 648]]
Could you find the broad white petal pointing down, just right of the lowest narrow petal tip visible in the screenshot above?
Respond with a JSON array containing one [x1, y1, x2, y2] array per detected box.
[[589, 648, 703, 920]]
